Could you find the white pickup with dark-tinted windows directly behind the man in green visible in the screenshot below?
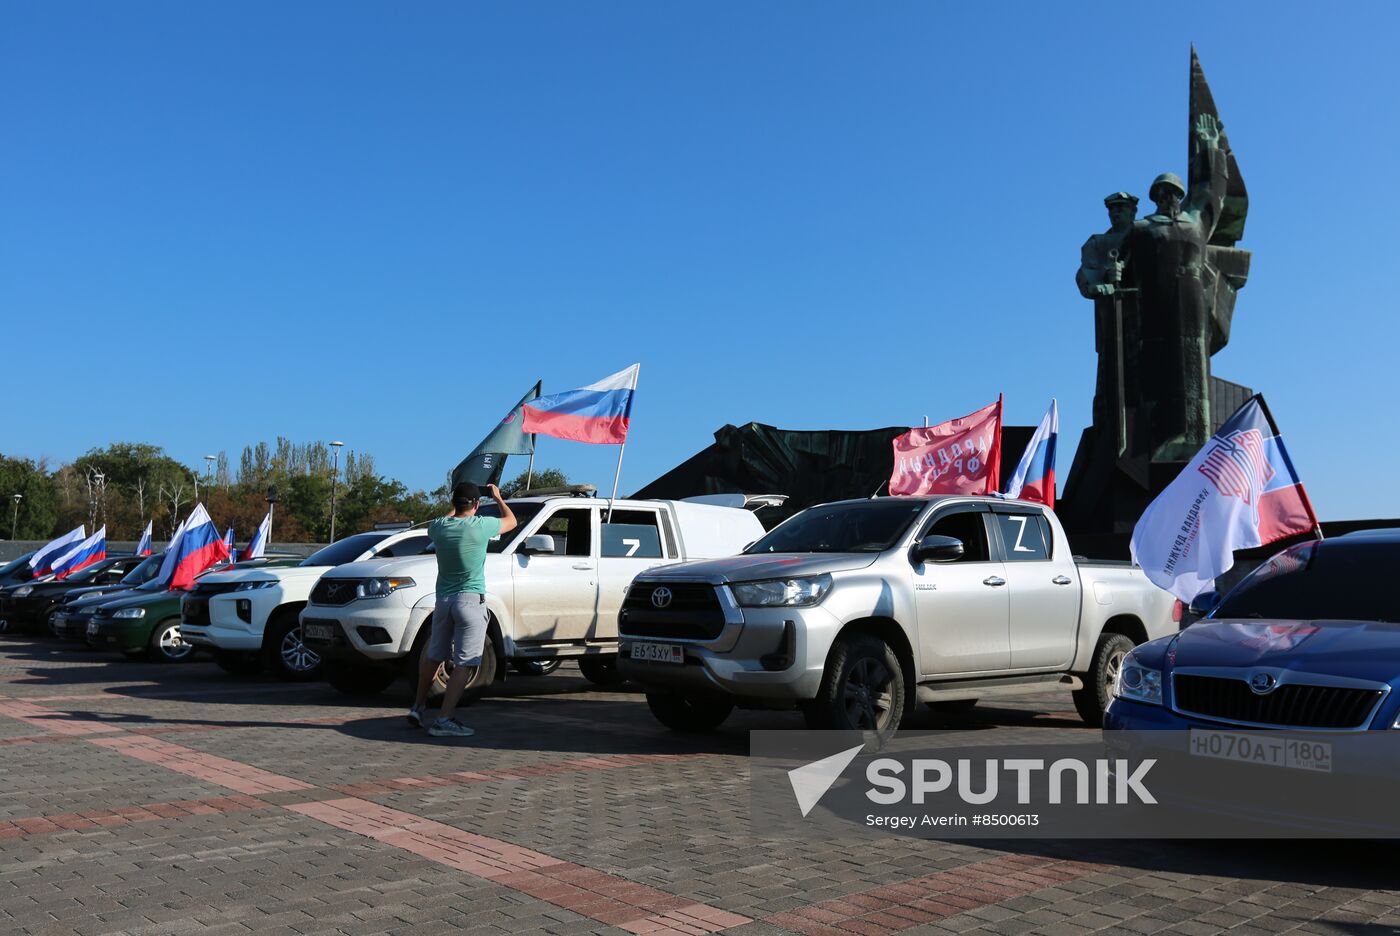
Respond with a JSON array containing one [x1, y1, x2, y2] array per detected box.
[[301, 495, 771, 698]]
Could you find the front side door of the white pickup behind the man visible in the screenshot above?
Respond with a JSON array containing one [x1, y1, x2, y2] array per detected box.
[[511, 506, 598, 644]]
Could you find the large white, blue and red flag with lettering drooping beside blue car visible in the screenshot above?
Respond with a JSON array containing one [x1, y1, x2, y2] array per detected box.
[[1130, 395, 1319, 603]]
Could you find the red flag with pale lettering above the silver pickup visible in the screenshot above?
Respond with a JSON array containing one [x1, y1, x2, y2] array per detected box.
[[889, 396, 1001, 495]]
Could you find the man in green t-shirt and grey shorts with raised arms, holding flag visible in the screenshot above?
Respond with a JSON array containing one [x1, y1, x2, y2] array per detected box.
[[409, 481, 515, 737]]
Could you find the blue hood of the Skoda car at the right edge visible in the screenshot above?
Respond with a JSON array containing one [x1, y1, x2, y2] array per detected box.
[[1166, 618, 1400, 683]]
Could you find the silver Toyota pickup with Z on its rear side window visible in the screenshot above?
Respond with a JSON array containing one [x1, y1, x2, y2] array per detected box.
[[617, 497, 1177, 735]]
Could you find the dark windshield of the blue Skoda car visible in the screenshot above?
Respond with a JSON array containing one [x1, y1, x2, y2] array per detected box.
[[1211, 537, 1400, 621]]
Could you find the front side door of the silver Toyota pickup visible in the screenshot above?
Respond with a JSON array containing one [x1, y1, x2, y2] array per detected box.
[[913, 504, 1011, 676]]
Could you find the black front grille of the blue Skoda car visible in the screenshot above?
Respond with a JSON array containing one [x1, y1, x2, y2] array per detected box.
[[1172, 673, 1383, 728]]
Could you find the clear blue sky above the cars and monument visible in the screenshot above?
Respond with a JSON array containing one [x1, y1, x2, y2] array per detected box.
[[0, 0, 1400, 518]]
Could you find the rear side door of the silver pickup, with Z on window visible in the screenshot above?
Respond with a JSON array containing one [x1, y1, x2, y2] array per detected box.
[[991, 504, 1081, 670]]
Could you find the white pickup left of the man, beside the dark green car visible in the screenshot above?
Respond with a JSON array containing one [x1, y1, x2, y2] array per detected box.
[[179, 529, 430, 680]]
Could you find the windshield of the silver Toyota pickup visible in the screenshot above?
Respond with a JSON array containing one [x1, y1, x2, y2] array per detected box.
[[745, 497, 927, 554]]
